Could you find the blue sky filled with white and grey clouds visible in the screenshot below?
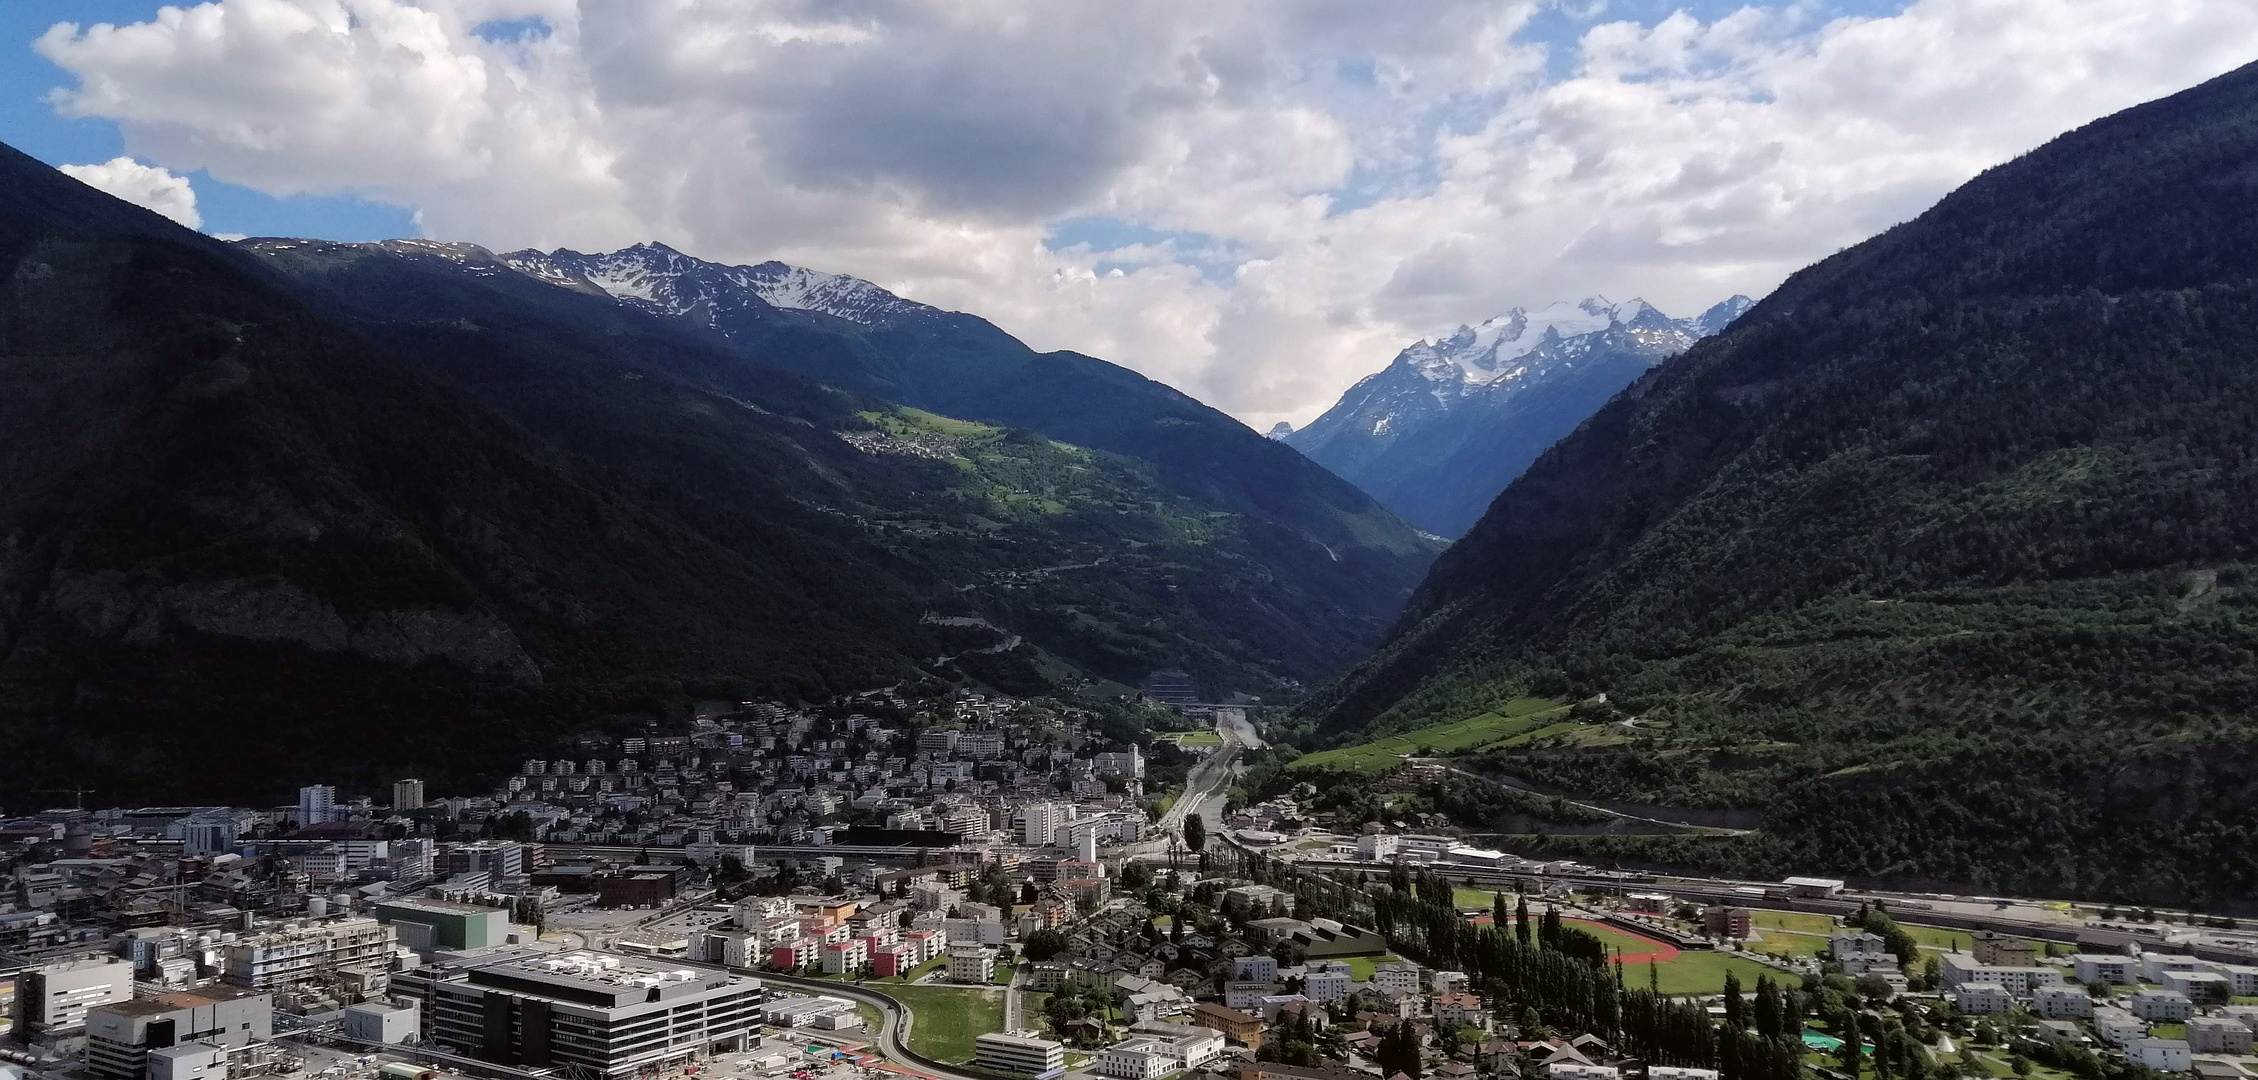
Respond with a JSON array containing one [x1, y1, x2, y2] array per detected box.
[[0, 0, 2258, 427]]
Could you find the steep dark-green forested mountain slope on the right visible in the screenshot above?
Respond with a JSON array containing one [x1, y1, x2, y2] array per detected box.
[[1307, 57, 2258, 904]]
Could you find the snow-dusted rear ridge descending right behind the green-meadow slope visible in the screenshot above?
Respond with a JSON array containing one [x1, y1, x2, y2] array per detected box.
[[501, 244, 1441, 619]]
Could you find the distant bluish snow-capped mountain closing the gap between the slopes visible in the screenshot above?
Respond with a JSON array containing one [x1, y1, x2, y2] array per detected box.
[[1274, 296, 1752, 538]]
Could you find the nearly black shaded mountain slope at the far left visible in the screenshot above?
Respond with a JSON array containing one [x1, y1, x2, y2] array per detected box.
[[0, 143, 930, 800]]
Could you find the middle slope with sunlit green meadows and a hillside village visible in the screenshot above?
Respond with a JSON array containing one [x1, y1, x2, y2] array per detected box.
[[244, 239, 1400, 696]]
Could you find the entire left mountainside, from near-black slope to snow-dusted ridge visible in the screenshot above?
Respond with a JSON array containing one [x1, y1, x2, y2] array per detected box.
[[0, 138, 1438, 802]]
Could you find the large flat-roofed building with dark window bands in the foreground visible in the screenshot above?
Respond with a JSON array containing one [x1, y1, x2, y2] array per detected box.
[[406, 951, 765, 1078]]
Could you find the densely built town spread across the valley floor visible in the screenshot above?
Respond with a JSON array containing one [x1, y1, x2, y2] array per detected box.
[[0, 691, 2258, 1080]]
